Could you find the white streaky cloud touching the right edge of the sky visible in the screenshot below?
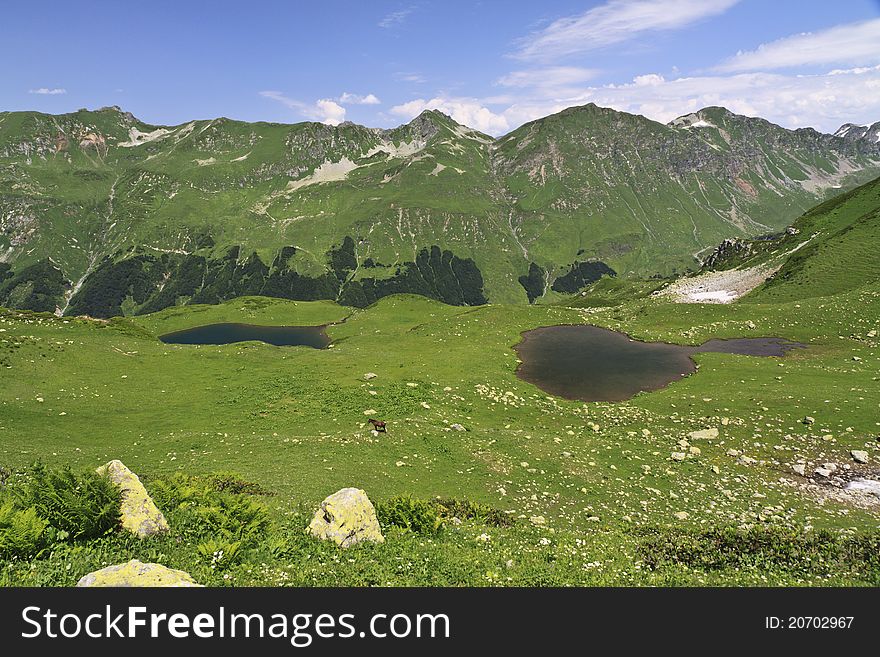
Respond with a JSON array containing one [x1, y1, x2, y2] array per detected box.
[[716, 18, 880, 72]]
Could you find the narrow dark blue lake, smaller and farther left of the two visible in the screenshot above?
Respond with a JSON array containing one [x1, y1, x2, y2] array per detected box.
[[159, 323, 330, 349]]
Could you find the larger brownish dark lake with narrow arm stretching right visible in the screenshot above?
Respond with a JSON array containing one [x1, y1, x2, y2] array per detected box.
[[515, 325, 806, 401]]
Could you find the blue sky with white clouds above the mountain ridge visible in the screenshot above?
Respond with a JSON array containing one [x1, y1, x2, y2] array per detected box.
[[0, 0, 880, 135]]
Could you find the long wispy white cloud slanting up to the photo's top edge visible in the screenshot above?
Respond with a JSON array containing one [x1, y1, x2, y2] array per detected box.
[[514, 0, 739, 61]]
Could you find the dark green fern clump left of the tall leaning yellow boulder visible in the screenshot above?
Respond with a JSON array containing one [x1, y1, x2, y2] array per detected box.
[[13, 463, 121, 539]]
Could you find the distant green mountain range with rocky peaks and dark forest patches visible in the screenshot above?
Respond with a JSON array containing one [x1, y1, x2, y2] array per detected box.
[[0, 105, 880, 317]]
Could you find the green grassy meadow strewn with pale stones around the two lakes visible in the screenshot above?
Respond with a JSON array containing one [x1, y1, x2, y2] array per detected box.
[[0, 276, 880, 585]]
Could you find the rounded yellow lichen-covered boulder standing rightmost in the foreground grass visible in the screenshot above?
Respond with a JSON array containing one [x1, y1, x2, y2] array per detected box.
[[309, 488, 385, 547]]
